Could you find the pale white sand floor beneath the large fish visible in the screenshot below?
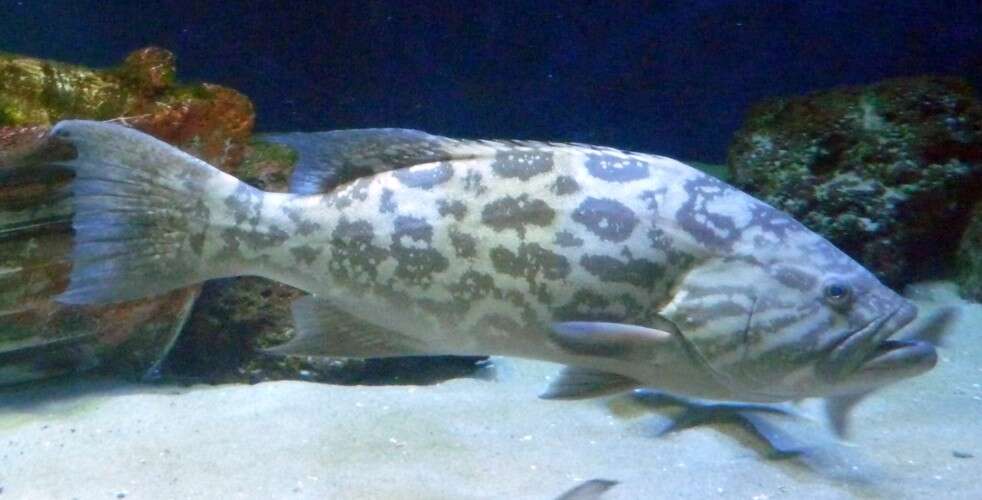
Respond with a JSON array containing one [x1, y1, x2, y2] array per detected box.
[[0, 284, 982, 500]]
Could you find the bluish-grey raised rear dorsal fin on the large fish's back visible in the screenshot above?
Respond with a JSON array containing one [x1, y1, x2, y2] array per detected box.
[[260, 128, 473, 194]]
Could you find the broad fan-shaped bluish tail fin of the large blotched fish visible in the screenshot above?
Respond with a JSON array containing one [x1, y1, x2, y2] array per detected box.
[[51, 120, 251, 304]]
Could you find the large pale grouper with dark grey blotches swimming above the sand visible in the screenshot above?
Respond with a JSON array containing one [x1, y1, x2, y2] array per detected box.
[[52, 121, 937, 426]]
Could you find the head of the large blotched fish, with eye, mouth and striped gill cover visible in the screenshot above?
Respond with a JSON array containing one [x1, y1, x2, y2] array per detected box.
[[663, 240, 937, 401]]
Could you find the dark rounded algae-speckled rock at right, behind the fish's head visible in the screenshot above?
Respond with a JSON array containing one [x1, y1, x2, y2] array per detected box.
[[729, 77, 982, 287]]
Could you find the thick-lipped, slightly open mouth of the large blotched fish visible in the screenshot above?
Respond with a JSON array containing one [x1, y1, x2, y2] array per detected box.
[[818, 302, 924, 381]]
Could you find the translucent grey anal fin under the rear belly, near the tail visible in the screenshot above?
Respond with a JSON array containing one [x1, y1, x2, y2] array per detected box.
[[266, 296, 433, 358]]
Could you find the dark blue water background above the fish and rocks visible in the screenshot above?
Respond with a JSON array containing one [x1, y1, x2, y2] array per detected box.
[[0, 0, 982, 162]]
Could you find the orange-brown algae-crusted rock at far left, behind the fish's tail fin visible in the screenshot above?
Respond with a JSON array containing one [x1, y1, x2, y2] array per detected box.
[[0, 48, 254, 384]]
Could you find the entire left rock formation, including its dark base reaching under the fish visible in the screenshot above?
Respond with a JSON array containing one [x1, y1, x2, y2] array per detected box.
[[0, 48, 480, 385]]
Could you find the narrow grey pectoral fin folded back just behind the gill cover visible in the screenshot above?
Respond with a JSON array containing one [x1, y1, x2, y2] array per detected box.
[[551, 321, 674, 361]]
